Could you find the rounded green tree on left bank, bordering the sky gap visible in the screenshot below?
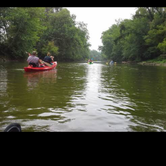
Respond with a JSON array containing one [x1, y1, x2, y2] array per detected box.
[[37, 9, 89, 61]]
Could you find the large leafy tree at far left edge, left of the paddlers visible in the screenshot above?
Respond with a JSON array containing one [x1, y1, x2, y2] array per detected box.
[[1, 7, 45, 59]]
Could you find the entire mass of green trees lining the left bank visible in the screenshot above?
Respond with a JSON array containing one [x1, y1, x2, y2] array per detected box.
[[0, 7, 90, 61]]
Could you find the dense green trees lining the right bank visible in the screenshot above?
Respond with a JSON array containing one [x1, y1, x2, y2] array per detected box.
[[99, 7, 166, 62]]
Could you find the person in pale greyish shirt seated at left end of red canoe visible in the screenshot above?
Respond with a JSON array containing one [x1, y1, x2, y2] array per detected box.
[[27, 51, 43, 67]]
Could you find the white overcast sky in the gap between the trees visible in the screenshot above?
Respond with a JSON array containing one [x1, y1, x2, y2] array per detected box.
[[66, 7, 137, 51]]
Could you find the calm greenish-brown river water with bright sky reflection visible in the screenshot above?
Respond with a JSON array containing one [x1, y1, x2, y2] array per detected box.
[[0, 62, 166, 132]]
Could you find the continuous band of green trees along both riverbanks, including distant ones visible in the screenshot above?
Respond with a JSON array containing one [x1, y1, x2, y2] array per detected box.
[[0, 7, 166, 66]]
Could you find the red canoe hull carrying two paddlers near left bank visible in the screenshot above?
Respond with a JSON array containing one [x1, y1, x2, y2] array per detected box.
[[24, 61, 57, 72]]
